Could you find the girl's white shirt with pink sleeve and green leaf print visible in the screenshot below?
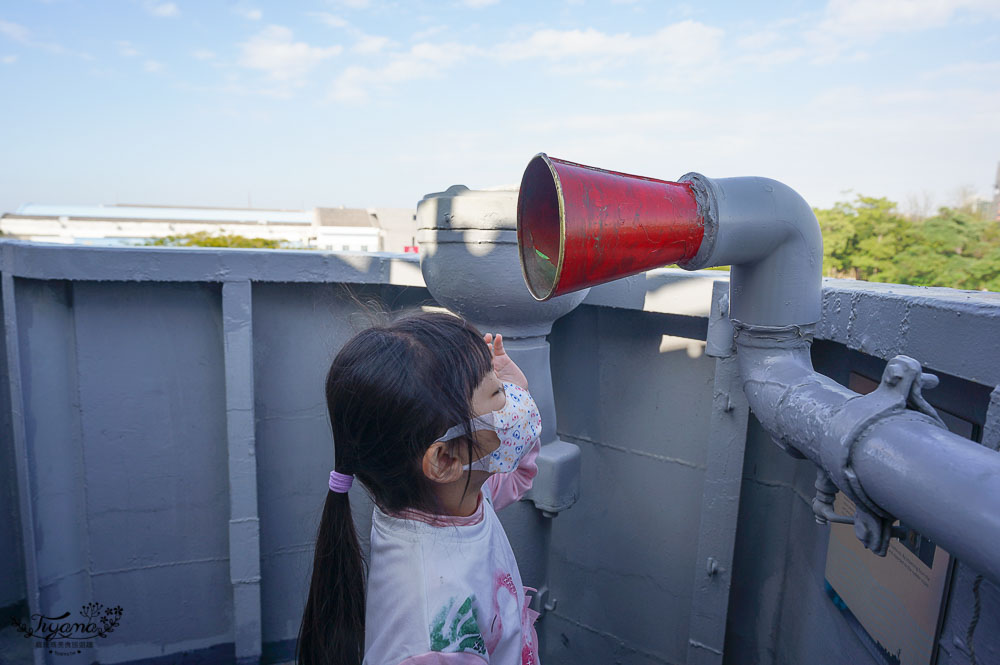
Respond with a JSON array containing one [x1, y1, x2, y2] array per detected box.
[[363, 443, 538, 665]]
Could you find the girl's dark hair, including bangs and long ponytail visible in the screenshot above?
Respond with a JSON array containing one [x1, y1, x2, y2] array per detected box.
[[295, 312, 492, 665]]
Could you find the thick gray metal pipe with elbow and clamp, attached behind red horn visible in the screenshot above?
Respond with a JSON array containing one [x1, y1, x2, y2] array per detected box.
[[681, 173, 1000, 582]]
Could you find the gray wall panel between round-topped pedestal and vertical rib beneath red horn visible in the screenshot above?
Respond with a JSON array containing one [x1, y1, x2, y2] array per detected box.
[[542, 305, 715, 665]]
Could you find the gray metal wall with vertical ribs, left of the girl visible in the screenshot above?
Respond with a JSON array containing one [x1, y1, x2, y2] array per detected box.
[[0, 243, 434, 664]]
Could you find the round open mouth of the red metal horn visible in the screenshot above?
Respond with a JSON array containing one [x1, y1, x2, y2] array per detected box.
[[517, 153, 566, 300]]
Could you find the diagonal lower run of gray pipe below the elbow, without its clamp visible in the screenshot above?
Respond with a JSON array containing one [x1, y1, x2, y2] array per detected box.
[[736, 330, 1000, 582]]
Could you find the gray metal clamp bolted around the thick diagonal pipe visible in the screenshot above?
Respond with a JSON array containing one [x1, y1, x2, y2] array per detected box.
[[813, 356, 945, 556]]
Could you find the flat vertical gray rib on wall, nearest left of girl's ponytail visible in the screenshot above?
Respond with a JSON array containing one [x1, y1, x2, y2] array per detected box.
[[222, 280, 263, 665]]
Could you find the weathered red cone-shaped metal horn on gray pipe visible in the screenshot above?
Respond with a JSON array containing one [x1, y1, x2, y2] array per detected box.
[[517, 153, 705, 300]]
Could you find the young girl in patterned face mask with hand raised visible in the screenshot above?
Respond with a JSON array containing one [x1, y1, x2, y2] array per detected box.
[[296, 313, 541, 665]]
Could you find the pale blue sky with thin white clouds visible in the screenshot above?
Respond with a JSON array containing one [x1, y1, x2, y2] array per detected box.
[[0, 0, 1000, 211]]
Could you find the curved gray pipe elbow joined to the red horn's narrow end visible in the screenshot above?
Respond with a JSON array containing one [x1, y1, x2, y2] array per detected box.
[[680, 173, 823, 327]]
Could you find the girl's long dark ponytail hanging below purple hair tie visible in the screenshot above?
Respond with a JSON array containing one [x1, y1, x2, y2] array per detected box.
[[295, 482, 366, 665]]
